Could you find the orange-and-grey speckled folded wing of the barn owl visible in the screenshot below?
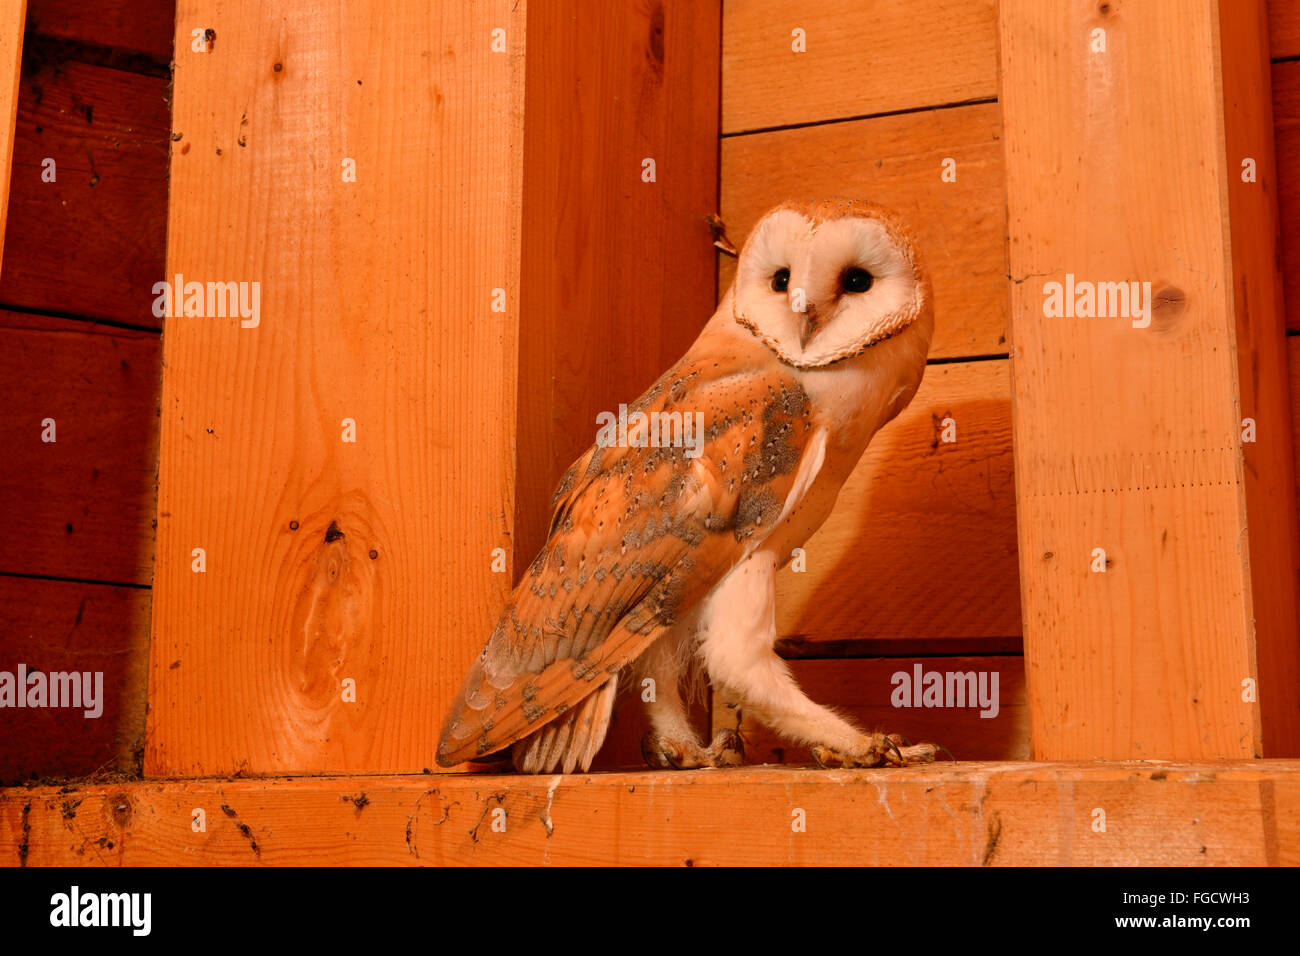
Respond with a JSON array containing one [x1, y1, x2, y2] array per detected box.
[[438, 363, 826, 766]]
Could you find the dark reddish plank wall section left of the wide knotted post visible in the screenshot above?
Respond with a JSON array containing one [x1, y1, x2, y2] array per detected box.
[[0, 0, 173, 782]]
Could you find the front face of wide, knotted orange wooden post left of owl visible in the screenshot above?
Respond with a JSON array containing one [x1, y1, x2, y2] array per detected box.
[[146, 0, 524, 775]]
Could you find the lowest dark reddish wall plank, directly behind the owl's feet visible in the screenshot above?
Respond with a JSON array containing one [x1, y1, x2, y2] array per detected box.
[[714, 656, 1030, 766]]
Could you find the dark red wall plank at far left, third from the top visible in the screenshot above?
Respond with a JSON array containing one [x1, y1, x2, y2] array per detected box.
[[0, 311, 161, 585]]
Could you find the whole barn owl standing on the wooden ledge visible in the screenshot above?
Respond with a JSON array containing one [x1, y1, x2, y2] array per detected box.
[[437, 200, 935, 773]]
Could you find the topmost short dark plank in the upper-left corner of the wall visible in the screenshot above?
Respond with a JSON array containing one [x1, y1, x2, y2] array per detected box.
[[30, 0, 176, 61]]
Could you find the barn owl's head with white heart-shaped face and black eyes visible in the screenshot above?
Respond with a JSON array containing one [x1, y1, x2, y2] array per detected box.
[[733, 199, 933, 369]]
